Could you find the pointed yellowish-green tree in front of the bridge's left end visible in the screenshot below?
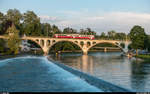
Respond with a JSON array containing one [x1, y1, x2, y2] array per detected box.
[[6, 24, 20, 54]]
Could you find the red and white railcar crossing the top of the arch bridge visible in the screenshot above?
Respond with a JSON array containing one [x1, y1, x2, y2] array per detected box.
[[54, 34, 95, 40]]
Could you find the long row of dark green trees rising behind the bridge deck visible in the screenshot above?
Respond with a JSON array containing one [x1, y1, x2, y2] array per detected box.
[[0, 9, 129, 40]]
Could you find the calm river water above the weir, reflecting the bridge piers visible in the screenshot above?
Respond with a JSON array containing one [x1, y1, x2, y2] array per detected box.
[[51, 52, 150, 92]]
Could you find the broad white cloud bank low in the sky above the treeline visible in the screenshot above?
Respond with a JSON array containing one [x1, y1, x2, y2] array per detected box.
[[38, 10, 150, 34]]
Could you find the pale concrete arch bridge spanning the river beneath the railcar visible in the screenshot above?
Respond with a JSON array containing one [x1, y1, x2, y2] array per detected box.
[[0, 36, 131, 55]]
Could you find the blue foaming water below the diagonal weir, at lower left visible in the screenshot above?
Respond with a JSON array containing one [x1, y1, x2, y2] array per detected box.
[[0, 56, 101, 92]]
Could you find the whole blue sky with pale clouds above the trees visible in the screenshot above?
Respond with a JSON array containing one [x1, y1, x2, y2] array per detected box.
[[0, 0, 150, 34]]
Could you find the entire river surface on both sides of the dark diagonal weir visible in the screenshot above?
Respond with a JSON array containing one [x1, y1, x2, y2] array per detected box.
[[0, 52, 150, 92]]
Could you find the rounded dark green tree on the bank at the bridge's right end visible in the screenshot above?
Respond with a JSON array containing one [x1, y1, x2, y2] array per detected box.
[[129, 25, 146, 55]]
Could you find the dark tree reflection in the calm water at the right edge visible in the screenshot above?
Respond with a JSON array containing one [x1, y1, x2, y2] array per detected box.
[[131, 61, 150, 91]]
